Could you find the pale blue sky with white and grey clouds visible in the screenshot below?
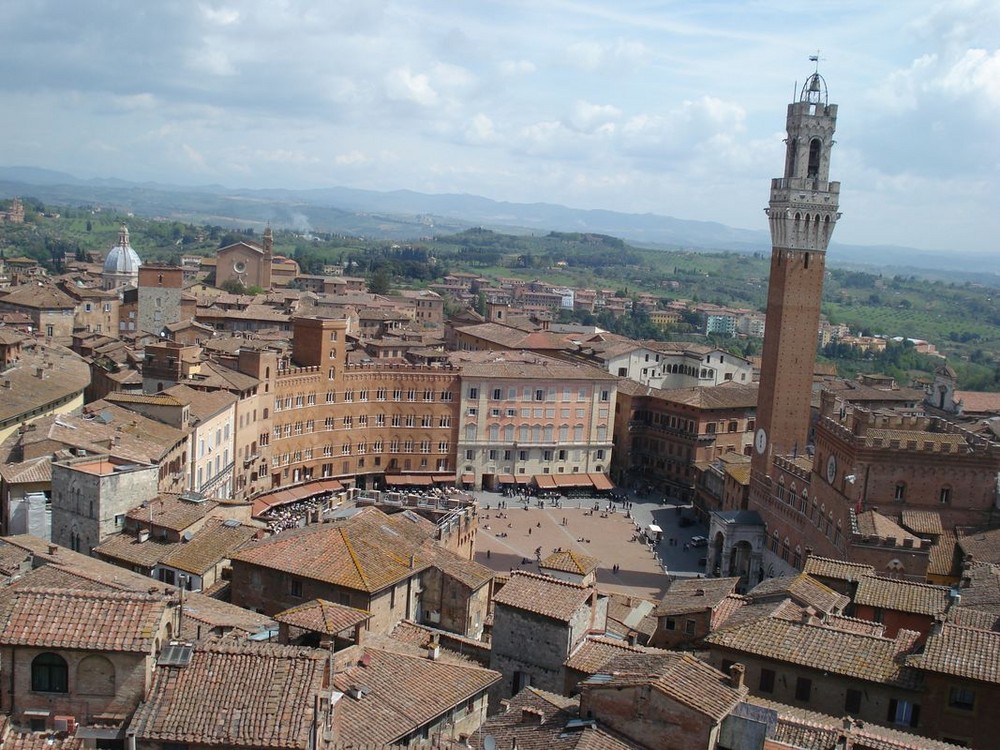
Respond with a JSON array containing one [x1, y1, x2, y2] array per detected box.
[[0, 0, 1000, 252]]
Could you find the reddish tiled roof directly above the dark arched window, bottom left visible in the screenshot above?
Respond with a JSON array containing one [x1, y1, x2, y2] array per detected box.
[[0, 592, 167, 653]]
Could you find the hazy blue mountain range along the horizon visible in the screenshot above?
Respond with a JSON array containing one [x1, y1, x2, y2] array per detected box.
[[0, 167, 1000, 276]]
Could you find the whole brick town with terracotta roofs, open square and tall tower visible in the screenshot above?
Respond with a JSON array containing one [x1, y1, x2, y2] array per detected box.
[[0, 71, 1000, 750]]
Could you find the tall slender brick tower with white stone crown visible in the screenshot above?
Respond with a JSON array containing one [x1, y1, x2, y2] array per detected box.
[[752, 72, 840, 479]]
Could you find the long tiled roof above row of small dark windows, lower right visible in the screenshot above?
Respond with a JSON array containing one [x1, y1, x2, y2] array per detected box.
[[705, 617, 918, 686]]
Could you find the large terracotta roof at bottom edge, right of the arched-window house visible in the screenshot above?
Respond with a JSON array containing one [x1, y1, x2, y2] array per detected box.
[[129, 641, 329, 748]]
